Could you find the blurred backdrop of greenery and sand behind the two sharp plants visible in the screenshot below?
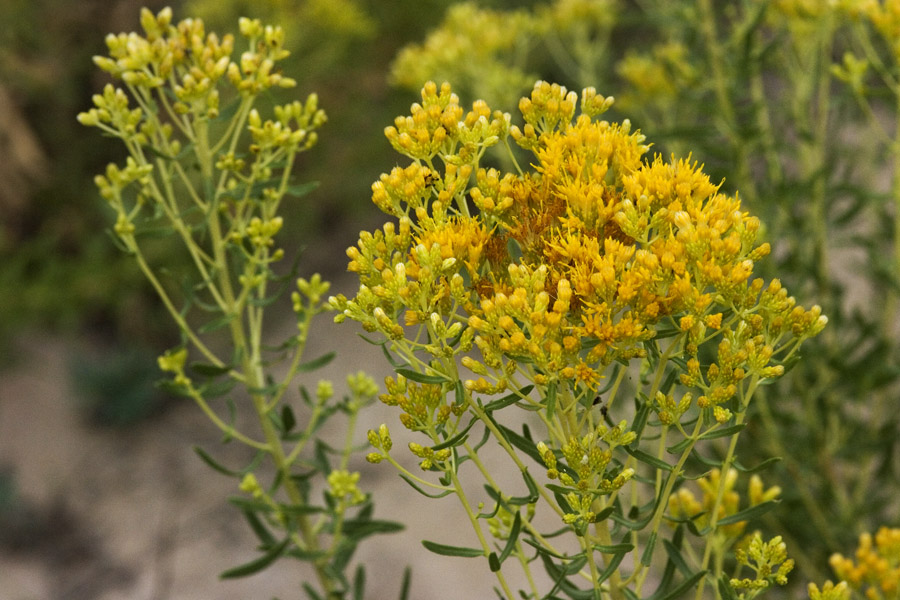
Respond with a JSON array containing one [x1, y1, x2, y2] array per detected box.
[[0, 0, 900, 600]]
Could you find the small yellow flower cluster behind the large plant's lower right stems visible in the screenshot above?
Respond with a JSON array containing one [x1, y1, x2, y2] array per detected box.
[[668, 469, 781, 538]]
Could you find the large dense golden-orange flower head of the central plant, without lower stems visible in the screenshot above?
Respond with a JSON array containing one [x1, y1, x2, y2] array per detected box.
[[332, 82, 826, 422]]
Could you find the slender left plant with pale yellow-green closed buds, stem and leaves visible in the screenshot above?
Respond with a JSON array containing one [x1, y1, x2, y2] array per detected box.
[[78, 8, 401, 600]]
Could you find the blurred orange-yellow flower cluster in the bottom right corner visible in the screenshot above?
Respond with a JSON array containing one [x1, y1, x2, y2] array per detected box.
[[829, 527, 900, 600]]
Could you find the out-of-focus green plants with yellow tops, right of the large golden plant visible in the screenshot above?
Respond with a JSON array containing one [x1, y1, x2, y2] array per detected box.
[[395, 0, 900, 592]]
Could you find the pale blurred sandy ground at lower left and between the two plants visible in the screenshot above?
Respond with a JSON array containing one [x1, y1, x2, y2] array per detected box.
[[0, 274, 556, 600]]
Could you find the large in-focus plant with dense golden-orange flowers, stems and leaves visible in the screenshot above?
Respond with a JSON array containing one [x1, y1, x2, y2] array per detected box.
[[330, 82, 827, 598]]
